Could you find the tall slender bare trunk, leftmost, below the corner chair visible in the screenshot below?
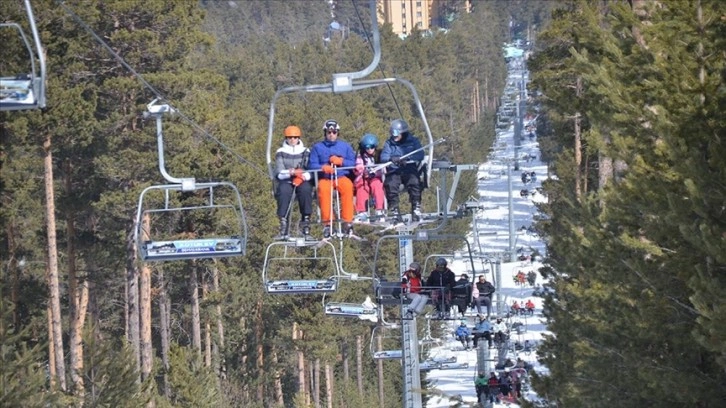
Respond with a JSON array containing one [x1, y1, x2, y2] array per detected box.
[[43, 136, 68, 391]]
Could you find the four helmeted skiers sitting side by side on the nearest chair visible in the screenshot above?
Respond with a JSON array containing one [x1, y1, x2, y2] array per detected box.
[[275, 119, 424, 240]]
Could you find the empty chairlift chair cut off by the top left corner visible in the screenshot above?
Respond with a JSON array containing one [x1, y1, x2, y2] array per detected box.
[[0, 0, 46, 111]]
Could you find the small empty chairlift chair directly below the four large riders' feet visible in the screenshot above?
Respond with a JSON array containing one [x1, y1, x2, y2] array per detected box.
[[262, 238, 340, 294]]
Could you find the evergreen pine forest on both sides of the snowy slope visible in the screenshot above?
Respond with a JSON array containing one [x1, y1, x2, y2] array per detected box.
[[0, 0, 726, 408]]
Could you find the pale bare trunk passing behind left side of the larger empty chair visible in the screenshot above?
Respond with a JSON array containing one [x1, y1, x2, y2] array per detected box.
[[139, 214, 154, 381]]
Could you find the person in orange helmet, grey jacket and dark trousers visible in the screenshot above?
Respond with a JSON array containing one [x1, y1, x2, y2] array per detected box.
[[275, 126, 313, 240]]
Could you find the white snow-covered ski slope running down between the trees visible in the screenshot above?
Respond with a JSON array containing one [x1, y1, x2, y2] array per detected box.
[[419, 59, 547, 408]]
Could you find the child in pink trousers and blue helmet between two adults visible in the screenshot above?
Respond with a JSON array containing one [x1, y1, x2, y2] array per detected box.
[[353, 133, 386, 222]]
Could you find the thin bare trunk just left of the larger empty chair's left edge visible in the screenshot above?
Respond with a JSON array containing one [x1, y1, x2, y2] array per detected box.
[[126, 227, 141, 382]]
